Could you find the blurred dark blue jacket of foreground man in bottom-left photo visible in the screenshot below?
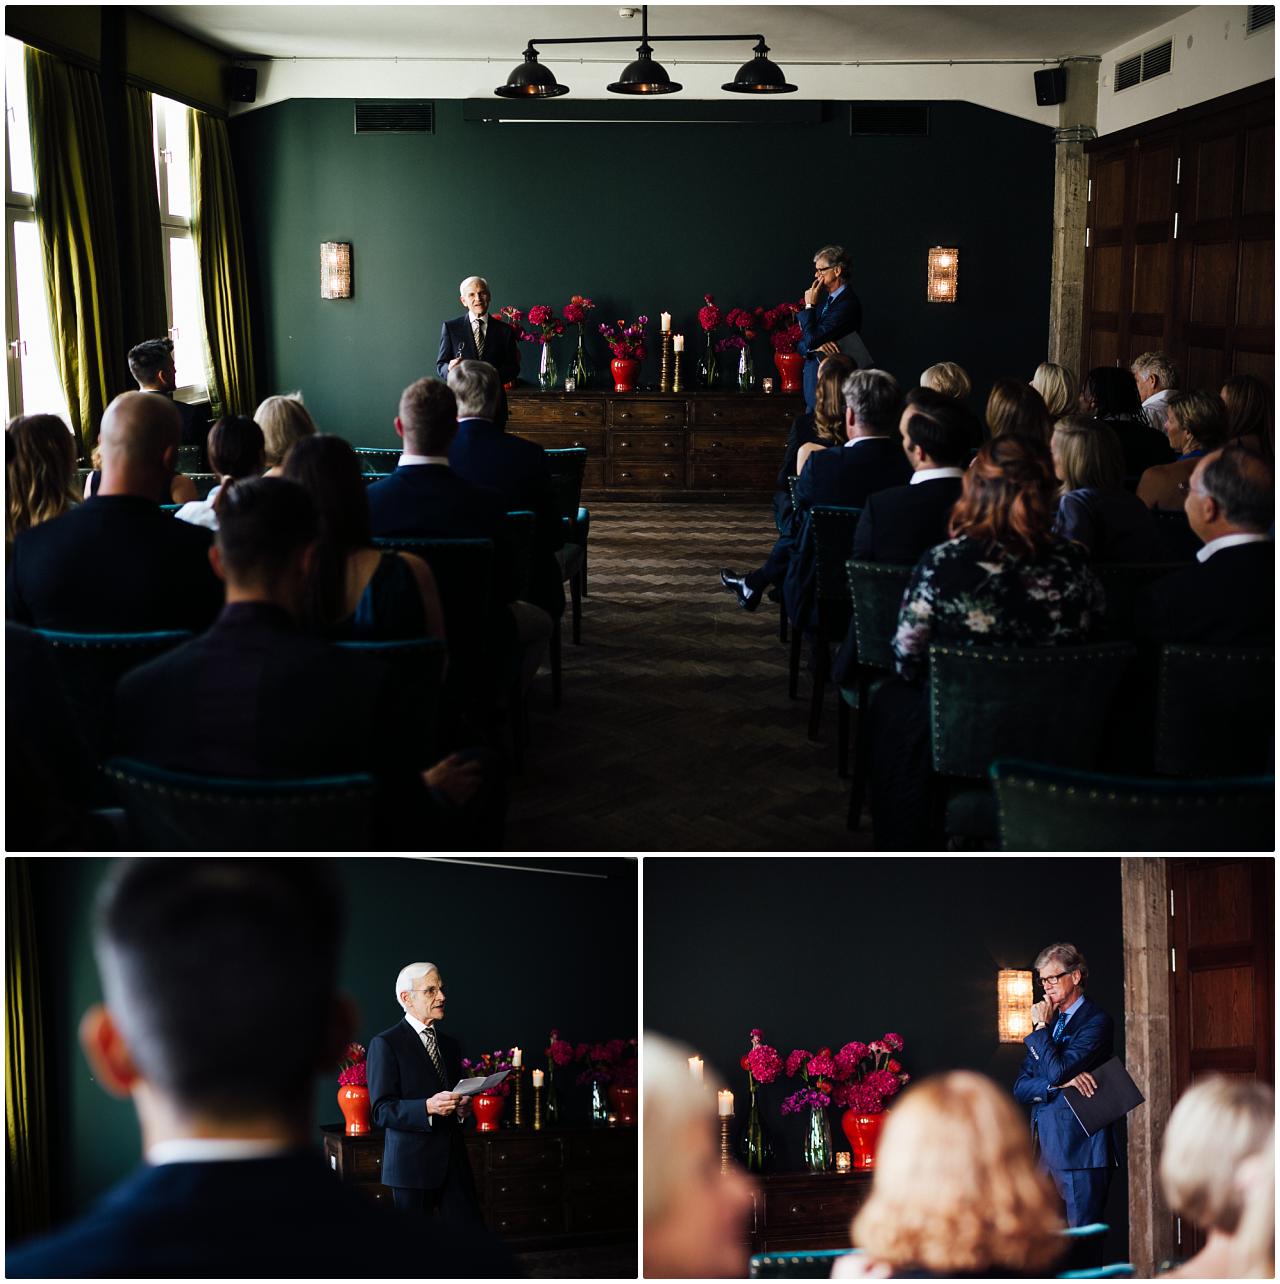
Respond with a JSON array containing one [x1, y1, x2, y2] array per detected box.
[[5, 1153, 514, 1279]]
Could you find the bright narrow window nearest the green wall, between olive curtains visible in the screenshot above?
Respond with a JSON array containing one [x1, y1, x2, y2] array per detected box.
[[151, 94, 209, 401]]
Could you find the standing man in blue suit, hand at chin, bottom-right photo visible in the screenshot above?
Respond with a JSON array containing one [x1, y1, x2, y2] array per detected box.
[[1013, 942, 1117, 1226]]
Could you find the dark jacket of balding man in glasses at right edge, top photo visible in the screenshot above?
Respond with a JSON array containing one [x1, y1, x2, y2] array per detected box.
[[1134, 539, 1276, 646]]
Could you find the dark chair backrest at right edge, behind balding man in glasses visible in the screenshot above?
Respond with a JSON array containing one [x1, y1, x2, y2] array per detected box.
[[1153, 645, 1275, 777]]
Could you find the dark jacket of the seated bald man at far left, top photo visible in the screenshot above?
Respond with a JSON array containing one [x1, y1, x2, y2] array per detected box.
[[5, 494, 223, 631]]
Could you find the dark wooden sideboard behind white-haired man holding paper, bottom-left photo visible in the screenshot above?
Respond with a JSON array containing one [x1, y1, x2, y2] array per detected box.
[[321, 1124, 637, 1251]]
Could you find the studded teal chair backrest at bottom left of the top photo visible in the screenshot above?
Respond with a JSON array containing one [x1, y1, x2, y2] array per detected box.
[[103, 758, 376, 851]]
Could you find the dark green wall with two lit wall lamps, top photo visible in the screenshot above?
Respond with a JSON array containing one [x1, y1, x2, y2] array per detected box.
[[231, 100, 1054, 446]]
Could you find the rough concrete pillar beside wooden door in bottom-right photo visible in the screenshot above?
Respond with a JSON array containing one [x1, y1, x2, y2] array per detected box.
[[1120, 856, 1173, 1279]]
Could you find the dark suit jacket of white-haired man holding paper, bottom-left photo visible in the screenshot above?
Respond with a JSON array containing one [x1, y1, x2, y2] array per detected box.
[[367, 1018, 469, 1190]]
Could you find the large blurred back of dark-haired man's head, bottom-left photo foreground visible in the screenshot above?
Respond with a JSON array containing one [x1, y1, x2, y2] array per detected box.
[[94, 856, 343, 1118]]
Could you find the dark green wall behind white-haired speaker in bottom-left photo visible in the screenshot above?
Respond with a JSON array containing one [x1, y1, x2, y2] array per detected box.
[[32, 856, 638, 1220]]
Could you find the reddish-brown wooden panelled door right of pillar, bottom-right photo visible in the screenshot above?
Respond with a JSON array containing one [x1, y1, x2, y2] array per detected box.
[[1167, 856, 1275, 1258]]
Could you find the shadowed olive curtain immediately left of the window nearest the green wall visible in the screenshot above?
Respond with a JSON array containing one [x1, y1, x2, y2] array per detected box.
[[121, 85, 168, 351]]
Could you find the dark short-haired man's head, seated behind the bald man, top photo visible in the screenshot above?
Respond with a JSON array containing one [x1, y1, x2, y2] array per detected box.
[[217, 478, 318, 596]]
